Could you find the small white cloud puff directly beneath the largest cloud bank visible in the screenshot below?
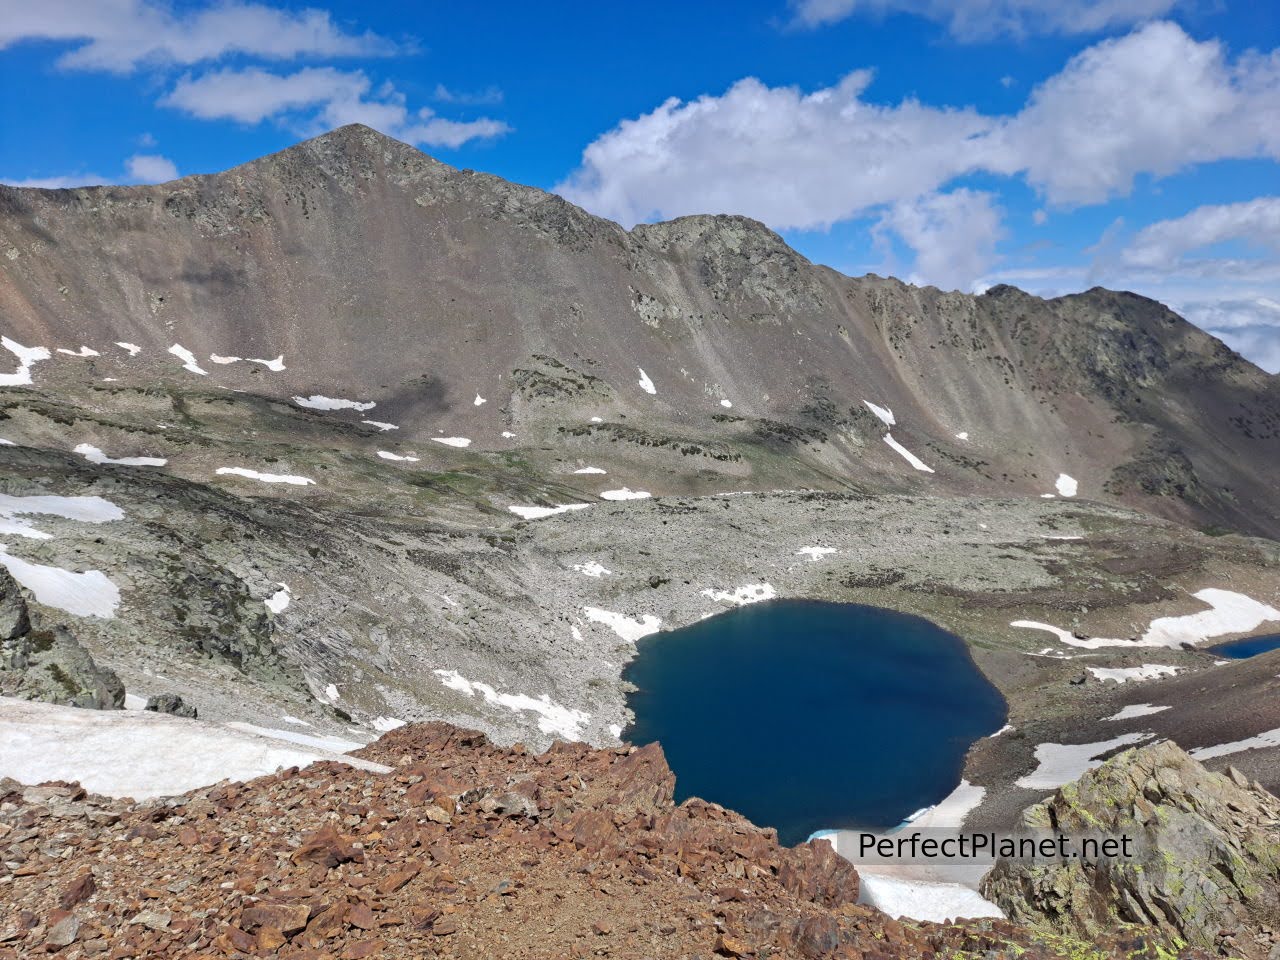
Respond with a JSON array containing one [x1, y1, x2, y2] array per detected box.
[[876, 189, 1004, 291]]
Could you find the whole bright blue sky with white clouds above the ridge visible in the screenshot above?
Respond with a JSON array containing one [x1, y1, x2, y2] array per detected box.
[[0, 0, 1280, 371]]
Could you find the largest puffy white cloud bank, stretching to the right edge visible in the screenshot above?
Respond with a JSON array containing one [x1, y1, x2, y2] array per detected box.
[[557, 23, 1280, 229]]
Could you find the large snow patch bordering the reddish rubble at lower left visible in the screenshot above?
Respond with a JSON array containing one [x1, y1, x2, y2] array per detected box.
[[0, 698, 389, 800]]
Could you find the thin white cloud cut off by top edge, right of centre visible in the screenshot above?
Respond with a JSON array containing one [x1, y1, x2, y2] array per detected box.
[[791, 0, 1179, 40]]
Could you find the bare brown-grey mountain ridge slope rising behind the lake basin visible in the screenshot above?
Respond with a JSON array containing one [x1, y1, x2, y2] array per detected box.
[[0, 127, 1280, 536]]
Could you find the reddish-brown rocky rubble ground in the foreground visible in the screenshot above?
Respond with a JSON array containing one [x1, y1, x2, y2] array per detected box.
[[0, 723, 1228, 960]]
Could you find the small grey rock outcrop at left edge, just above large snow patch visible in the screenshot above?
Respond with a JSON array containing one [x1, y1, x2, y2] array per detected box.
[[0, 627, 124, 710]]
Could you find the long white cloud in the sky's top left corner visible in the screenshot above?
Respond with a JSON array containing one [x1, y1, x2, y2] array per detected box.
[[0, 0, 393, 73]]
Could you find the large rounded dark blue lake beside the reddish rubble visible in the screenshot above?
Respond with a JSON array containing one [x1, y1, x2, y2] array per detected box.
[[623, 600, 1006, 845]]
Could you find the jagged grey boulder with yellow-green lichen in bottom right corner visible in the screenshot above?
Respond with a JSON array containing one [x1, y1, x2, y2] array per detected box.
[[982, 741, 1280, 957]]
